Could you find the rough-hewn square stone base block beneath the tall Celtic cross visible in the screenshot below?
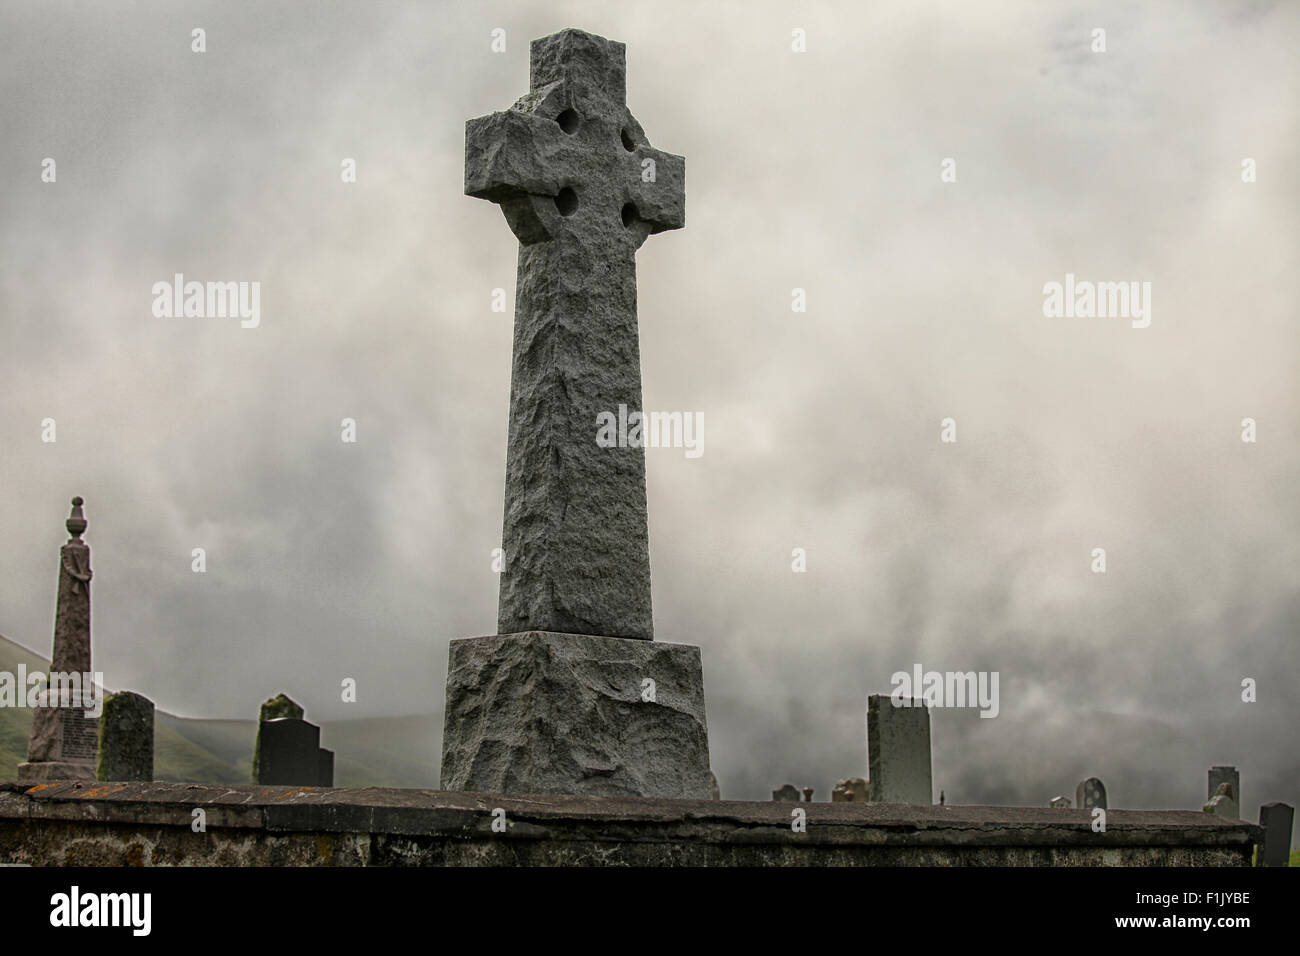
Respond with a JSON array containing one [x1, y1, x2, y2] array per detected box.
[[441, 631, 711, 800]]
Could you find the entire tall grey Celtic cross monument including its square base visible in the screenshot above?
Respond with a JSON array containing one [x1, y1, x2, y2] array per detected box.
[[442, 30, 710, 799]]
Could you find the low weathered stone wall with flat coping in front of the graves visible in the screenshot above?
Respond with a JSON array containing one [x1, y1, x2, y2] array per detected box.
[[0, 782, 1261, 866]]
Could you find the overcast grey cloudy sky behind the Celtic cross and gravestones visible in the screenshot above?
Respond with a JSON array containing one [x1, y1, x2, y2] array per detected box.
[[0, 1, 1300, 818]]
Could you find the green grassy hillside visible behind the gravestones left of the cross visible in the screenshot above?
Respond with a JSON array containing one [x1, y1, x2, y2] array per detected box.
[[0, 637, 442, 787]]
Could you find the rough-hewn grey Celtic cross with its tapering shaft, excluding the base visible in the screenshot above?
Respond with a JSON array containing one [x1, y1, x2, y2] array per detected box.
[[465, 30, 685, 640]]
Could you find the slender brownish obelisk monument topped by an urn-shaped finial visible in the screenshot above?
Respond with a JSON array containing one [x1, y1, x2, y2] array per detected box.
[[18, 497, 101, 783]]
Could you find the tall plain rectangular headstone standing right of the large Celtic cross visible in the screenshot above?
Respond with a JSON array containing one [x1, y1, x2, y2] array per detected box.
[[867, 693, 935, 806]]
